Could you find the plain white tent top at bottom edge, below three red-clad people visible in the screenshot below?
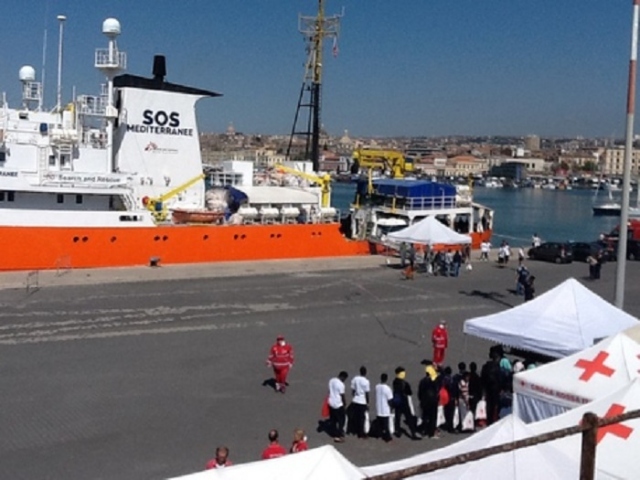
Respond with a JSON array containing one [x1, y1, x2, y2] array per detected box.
[[166, 445, 365, 480]]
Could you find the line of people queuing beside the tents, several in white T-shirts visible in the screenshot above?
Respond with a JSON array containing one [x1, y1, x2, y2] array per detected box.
[[325, 347, 533, 443]]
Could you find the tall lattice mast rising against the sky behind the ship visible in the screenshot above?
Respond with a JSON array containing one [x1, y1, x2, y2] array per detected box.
[[287, 0, 343, 172]]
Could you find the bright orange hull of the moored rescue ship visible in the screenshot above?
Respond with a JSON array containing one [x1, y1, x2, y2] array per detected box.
[[0, 223, 371, 271]]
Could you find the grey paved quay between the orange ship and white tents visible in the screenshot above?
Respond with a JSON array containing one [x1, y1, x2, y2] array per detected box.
[[0, 253, 640, 480]]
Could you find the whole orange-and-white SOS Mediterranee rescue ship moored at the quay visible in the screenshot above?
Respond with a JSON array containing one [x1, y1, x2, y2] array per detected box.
[[0, 18, 490, 270]]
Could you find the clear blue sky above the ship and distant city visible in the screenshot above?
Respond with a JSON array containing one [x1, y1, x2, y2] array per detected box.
[[0, 0, 640, 137]]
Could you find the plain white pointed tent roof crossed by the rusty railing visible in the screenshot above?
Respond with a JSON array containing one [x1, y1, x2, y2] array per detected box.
[[362, 415, 579, 480]]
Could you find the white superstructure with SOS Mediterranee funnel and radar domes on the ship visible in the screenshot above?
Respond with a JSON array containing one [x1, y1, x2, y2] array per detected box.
[[0, 15, 217, 227]]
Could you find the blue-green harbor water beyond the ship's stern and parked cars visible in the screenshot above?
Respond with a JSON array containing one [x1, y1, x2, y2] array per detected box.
[[332, 183, 635, 246]]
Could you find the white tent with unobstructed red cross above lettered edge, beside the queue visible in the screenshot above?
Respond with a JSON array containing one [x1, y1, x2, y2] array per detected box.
[[513, 326, 640, 422]]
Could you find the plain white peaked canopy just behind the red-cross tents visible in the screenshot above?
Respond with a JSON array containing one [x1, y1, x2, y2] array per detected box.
[[463, 278, 638, 358]]
